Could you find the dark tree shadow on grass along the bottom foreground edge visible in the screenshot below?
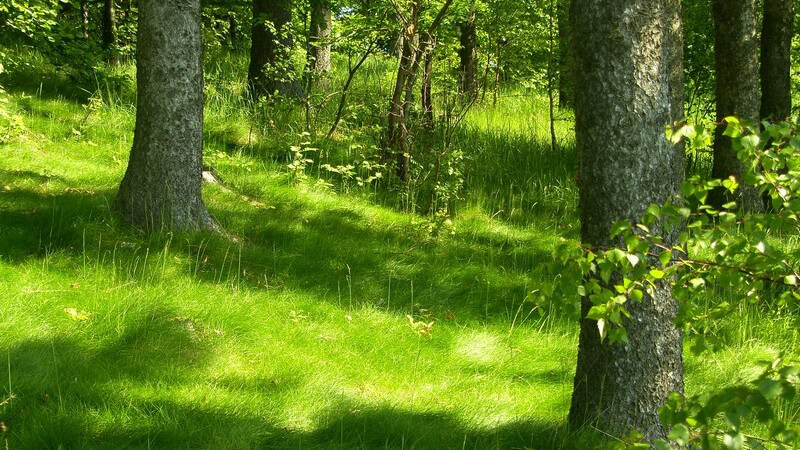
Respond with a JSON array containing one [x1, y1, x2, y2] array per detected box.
[[0, 302, 592, 449]]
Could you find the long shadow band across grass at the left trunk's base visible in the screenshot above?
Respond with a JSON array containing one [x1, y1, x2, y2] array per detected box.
[[0, 166, 549, 319]]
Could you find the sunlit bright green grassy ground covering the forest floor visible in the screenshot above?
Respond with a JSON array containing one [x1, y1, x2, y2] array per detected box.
[[0, 51, 797, 449]]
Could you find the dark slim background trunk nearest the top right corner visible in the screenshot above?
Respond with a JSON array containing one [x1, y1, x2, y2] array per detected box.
[[761, 0, 793, 120]]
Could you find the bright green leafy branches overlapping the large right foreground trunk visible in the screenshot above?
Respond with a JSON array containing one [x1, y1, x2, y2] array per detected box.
[[564, 117, 800, 449]]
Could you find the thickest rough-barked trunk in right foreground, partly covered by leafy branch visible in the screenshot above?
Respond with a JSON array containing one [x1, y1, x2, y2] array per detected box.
[[569, 0, 683, 439]]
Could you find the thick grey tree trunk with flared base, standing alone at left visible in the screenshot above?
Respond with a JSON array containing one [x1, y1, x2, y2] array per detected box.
[[116, 0, 214, 231]]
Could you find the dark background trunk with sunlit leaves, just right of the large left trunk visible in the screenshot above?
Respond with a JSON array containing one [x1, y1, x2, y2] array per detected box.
[[248, 0, 300, 99]]
